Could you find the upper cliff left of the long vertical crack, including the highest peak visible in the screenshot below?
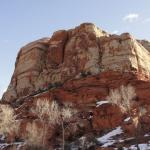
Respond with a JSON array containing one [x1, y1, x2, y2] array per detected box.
[[3, 24, 107, 101]]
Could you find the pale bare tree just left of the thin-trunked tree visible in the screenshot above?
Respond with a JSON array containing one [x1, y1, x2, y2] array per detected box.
[[28, 99, 59, 145]]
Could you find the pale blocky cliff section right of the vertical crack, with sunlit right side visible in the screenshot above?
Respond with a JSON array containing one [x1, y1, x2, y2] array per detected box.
[[100, 33, 150, 80]]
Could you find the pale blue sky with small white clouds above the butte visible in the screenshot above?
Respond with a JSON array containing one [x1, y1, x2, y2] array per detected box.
[[0, 0, 150, 98]]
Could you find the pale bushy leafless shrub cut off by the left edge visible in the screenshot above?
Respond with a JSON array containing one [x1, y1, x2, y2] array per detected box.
[[0, 105, 20, 136]]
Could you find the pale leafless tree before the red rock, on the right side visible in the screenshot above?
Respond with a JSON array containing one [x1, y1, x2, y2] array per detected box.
[[106, 85, 147, 149]]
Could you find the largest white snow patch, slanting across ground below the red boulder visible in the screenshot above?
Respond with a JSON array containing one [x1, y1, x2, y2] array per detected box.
[[97, 126, 123, 147]]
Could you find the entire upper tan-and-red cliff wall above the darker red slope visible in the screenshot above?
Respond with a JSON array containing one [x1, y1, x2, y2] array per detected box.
[[2, 23, 150, 102]]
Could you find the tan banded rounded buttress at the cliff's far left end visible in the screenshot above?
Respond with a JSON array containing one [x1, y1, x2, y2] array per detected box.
[[3, 38, 49, 101]]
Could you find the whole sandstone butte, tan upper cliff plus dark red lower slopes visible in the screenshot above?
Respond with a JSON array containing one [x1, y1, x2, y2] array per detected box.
[[2, 23, 150, 149]]
